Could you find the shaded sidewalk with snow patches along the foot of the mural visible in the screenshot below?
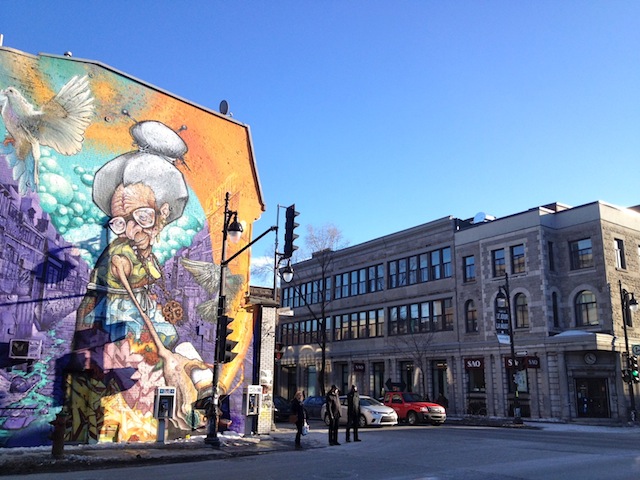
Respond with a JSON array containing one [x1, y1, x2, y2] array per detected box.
[[0, 427, 316, 477]]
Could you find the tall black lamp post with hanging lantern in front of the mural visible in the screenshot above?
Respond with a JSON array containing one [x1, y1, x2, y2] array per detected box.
[[205, 192, 243, 447]]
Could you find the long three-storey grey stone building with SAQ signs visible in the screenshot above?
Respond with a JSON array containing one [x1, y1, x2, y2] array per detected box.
[[276, 202, 640, 421]]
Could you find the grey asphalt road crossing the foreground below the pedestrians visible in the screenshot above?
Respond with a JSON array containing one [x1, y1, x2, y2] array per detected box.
[[11, 422, 640, 480]]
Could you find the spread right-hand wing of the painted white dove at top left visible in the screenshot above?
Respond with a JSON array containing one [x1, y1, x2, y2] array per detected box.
[[29, 75, 94, 155]]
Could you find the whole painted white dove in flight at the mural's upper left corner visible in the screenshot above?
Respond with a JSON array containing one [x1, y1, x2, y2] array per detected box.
[[0, 75, 94, 190]]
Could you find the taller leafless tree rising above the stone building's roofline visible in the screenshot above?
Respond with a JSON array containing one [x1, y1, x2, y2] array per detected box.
[[294, 224, 348, 396]]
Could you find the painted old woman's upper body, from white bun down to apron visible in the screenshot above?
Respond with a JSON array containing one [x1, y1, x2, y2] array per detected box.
[[76, 122, 188, 345]]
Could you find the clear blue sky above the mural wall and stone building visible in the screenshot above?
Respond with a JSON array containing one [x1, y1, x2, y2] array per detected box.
[[0, 0, 640, 280]]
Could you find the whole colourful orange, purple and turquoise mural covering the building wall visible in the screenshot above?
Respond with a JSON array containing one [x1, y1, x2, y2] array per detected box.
[[0, 48, 259, 446]]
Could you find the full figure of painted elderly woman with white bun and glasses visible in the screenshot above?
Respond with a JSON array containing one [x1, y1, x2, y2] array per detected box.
[[68, 122, 208, 440]]
